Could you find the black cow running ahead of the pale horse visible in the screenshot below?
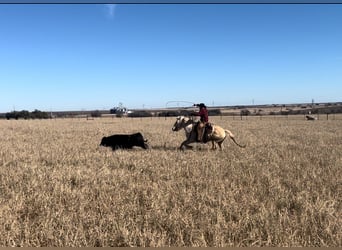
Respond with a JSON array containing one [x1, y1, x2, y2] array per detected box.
[[100, 133, 149, 150]]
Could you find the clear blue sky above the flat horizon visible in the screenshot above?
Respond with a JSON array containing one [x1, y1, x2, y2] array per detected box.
[[0, 4, 342, 112]]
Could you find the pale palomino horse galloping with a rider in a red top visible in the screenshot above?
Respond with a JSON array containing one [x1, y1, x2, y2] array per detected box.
[[172, 116, 246, 150]]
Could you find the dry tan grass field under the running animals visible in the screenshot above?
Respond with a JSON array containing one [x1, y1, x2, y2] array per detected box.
[[0, 116, 342, 247]]
